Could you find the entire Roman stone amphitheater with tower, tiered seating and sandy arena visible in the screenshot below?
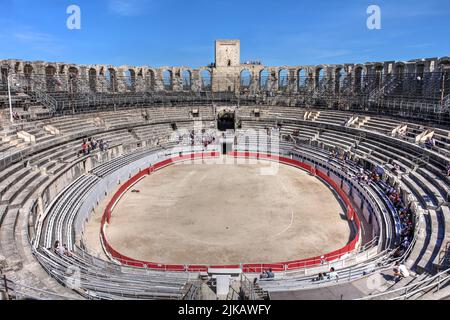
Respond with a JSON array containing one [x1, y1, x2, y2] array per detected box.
[[0, 40, 450, 300]]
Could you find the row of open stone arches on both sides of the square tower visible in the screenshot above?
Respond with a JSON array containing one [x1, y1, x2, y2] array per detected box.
[[2, 58, 450, 92]]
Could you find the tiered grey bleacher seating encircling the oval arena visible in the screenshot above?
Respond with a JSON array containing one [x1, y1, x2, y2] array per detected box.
[[0, 106, 450, 299]]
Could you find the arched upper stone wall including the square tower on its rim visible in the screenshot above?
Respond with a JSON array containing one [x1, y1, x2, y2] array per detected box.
[[0, 40, 450, 92]]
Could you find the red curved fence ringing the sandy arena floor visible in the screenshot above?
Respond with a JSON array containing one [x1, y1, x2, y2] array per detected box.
[[100, 152, 361, 273]]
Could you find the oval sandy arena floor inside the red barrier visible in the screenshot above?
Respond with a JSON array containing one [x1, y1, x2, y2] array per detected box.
[[96, 161, 351, 264]]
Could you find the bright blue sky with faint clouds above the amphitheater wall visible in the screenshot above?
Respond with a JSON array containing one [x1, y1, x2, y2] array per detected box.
[[0, 0, 450, 67]]
